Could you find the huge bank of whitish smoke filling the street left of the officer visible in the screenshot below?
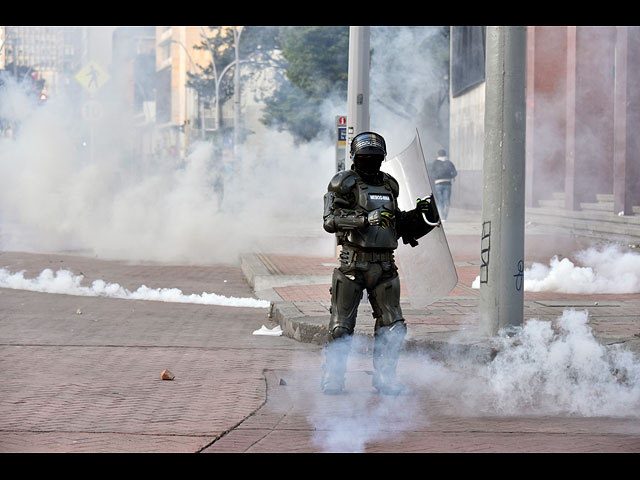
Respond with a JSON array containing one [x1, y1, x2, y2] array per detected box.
[[0, 63, 335, 264]]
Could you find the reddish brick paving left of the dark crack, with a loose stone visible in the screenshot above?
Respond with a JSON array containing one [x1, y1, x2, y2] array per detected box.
[[0, 253, 320, 452]]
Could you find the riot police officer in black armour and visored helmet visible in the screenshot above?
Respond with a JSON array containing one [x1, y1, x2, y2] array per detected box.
[[321, 132, 439, 395]]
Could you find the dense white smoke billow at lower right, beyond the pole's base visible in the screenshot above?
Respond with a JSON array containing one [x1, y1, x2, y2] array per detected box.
[[483, 310, 640, 417]]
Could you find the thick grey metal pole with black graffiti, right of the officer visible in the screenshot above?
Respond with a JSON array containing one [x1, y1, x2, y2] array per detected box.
[[480, 27, 527, 335]]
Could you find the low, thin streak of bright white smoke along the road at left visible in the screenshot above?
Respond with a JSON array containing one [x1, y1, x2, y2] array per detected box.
[[0, 268, 270, 308]]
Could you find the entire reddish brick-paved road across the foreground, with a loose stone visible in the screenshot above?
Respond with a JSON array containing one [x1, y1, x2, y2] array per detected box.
[[0, 252, 640, 453]]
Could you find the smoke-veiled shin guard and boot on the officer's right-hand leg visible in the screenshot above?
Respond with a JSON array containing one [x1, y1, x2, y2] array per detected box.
[[373, 320, 407, 395]]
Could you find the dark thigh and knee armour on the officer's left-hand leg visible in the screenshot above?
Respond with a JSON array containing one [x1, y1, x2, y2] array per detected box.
[[329, 268, 362, 338]]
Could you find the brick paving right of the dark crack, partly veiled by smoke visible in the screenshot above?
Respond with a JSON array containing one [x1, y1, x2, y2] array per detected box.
[[204, 370, 640, 453]]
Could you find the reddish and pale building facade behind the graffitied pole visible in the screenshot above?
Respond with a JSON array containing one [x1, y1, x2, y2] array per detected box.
[[450, 26, 640, 221]]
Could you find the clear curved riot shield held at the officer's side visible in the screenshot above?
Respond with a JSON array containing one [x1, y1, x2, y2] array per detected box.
[[381, 132, 458, 308]]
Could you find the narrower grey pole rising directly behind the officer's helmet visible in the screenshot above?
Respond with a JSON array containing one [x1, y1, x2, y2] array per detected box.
[[345, 27, 370, 169]]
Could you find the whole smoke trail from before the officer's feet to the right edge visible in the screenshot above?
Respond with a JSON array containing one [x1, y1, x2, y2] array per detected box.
[[304, 310, 640, 452]]
